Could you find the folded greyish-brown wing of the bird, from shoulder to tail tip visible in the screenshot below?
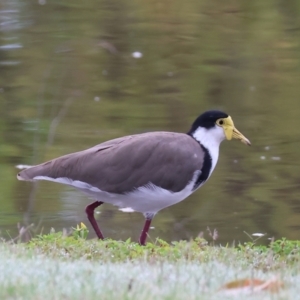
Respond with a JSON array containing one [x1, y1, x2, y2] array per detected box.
[[19, 132, 204, 194]]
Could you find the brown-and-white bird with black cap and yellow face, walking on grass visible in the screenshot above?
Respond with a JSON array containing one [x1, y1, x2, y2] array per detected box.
[[17, 110, 251, 245]]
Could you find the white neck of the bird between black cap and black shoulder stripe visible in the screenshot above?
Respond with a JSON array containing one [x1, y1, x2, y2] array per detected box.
[[193, 126, 226, 176]]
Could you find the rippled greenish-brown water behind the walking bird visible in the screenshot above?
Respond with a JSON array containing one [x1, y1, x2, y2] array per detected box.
[[0, 0, 300, 244]]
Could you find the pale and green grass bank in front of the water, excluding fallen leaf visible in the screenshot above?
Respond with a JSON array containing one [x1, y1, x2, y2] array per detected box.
[[0, 226, 300, 300]]
